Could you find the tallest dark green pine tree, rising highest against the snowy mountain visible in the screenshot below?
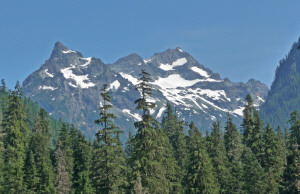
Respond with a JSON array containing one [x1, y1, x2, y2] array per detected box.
[[130, 70, 182, 193]]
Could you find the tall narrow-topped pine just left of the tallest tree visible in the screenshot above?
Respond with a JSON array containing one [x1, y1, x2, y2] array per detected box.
[[92, 84, 127, 193]]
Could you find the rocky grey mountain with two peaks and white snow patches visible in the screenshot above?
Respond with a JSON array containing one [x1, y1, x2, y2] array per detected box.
[[23, 42, 268, 138]]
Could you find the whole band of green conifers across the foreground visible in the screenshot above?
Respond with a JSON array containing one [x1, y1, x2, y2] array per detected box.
[[0, 70, 300, 194]]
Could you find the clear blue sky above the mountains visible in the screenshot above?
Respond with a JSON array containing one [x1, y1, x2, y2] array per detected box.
[[0, 0, 300, 87]]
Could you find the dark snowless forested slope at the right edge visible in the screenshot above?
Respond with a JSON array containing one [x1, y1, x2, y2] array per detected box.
[[260, 38, 300, 128]]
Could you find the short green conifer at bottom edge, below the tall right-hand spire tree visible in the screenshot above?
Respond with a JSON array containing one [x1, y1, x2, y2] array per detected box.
[[242, 147, 267, 193]]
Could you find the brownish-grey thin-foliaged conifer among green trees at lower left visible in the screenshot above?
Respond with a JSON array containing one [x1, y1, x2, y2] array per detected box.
[[55, 140, 72, 194]]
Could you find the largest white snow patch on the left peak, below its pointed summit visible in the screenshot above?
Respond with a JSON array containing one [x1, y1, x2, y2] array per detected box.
[[61, 64, 95, 88]]
